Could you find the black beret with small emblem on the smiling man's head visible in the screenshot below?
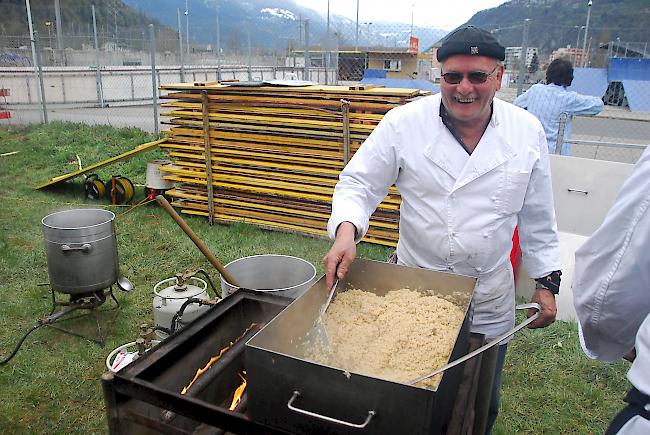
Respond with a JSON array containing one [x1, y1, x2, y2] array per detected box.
[[436, 26, 506, 62]]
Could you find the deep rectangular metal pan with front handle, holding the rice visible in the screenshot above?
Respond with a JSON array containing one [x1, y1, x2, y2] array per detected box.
[[246, 259, 476, 434]]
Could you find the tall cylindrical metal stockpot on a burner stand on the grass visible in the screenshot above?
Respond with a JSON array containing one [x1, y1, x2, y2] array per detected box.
[[41, 208, 118, 294]]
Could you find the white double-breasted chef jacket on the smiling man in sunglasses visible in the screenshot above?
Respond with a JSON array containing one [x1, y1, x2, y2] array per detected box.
[[328, 94, 560, 337]]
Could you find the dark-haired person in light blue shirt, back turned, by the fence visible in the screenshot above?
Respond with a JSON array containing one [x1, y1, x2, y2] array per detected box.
[[514, 59, 604, 156]]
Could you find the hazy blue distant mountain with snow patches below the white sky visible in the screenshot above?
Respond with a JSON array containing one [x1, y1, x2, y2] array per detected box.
[[124, 0, 446, 51]]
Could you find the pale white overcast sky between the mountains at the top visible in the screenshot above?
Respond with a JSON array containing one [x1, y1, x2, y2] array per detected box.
[[295, 0, 507, 30]]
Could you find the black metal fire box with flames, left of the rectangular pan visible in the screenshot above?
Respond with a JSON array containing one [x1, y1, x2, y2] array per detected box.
[[102, 290, 291, 435]]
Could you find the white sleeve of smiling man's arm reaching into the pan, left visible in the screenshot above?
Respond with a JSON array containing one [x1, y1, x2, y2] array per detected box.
[[327, 112, 399, 242]]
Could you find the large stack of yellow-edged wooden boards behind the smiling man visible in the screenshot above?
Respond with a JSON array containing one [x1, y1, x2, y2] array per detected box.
[[161, 83, 426, 246]]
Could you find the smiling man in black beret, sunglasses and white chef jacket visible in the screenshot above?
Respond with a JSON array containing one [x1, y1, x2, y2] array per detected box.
[[323, 26, 561, 433]]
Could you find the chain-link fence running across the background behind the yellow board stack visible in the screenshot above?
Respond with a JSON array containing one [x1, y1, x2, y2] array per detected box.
[[0, 5, 650, 163]]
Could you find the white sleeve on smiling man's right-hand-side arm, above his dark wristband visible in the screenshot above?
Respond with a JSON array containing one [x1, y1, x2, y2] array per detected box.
[[518, 125, 562, 278]]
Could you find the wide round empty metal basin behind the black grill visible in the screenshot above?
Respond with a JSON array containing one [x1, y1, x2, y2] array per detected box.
[[221, 254, 316, 299]]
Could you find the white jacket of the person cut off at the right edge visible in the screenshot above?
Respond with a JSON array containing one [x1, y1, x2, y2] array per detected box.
[[573, 148, 650, 433]]
